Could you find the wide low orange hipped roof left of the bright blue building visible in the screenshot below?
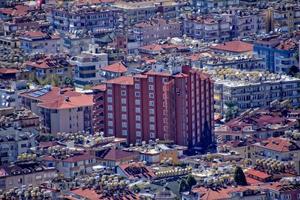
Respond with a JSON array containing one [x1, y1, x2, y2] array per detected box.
[[210, 40, 253, 53]]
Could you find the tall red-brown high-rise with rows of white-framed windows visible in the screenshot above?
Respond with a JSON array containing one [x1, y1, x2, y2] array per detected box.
[[95, 67, 213, 148]]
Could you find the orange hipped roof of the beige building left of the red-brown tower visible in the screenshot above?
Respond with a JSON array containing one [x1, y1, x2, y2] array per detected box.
[[38, 94, 94, 109]]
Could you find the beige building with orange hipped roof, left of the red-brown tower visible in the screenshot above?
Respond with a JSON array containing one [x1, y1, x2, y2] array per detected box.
[[20, 87, 94, 134]]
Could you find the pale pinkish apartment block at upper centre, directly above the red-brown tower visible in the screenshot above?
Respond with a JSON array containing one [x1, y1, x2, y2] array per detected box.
[[133, 19, 182, 46]]
